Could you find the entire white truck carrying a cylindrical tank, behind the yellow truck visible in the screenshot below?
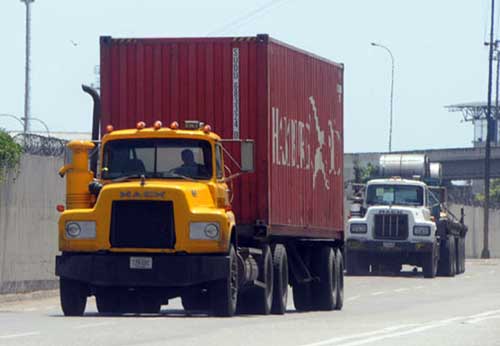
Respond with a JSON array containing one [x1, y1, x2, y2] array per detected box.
[[345, 154, 467, 278]]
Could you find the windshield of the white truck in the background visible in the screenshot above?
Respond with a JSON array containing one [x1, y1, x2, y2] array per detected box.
[[366, 185, 424, 205]]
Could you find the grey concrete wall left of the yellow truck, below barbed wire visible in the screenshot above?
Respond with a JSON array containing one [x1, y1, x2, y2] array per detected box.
[[0, 155, 65, 294]]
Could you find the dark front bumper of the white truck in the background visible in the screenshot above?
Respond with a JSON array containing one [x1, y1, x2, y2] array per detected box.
[[345, 239, 434, 253]]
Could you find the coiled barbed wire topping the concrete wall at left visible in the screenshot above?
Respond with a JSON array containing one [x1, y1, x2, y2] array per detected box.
[[13, 133, 67, 157]]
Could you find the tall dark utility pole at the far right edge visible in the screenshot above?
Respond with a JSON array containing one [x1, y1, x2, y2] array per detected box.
[[481, 0, 495, 258]]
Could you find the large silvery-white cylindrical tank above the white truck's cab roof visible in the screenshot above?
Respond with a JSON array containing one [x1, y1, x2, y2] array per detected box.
[[379, 154, 429, 178]]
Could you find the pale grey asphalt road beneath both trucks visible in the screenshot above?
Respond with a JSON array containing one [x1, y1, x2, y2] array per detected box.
[[0, 260, 500, 346]]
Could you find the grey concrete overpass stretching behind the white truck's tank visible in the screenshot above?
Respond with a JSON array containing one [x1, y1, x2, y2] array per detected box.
[[344, 146, 500, 181]]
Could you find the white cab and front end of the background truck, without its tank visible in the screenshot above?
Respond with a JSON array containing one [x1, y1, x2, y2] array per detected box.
[[345, 155, 465, 277]]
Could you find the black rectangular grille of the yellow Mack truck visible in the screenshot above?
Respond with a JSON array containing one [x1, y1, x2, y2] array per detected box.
[[110, 201, 175, 249]]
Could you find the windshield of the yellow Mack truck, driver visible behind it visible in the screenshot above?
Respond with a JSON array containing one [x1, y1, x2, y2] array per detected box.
[[102, 138, 212, 180]]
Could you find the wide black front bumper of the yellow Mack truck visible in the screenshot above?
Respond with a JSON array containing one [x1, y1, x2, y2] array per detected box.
[[56, 253, 229, 287]]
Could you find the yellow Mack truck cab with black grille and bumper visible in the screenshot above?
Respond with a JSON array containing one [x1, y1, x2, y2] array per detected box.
[[56, 122, 253, 315]]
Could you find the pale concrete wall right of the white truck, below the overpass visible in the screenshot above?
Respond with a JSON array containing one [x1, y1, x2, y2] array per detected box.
[[450, 205, 500, 258]]
